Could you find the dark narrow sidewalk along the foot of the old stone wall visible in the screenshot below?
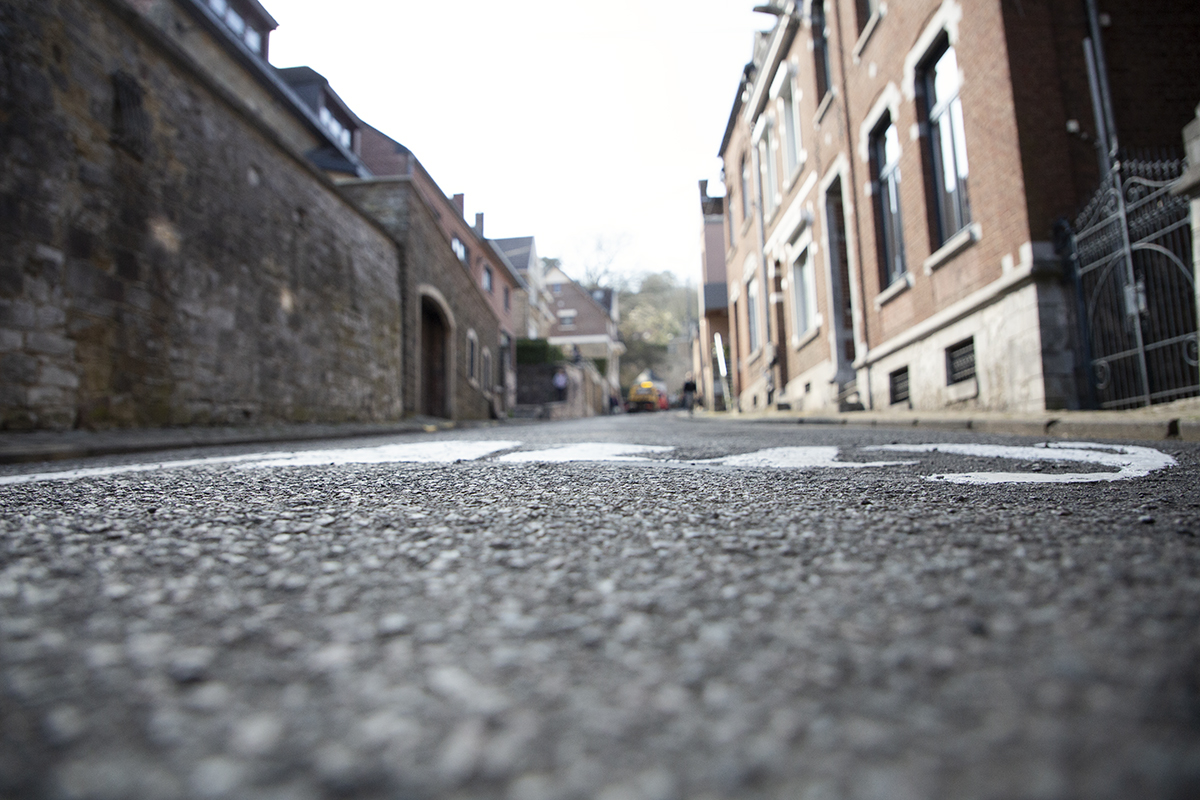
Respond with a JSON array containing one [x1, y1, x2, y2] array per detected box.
[[0, 417, 493, 464]]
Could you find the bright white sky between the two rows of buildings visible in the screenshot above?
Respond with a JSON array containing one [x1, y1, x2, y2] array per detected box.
[[263, 0, 772, 282]]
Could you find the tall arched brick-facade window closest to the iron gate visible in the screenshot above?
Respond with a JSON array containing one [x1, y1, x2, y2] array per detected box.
[[923, 37, 971, 247]]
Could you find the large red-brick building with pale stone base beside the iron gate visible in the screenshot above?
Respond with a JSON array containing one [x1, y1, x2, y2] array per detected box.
[[720, 0, 1200, 410]]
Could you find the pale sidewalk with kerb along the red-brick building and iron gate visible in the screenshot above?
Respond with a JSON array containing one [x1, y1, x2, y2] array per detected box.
[[706, 398, 1200, 441]]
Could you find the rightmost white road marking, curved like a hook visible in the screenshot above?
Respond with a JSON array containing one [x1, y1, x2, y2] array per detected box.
[[863, 441, 1178, 483]]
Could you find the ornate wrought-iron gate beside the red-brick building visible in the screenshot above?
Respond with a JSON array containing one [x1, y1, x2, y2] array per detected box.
[[1073, 158, 1200, 408]]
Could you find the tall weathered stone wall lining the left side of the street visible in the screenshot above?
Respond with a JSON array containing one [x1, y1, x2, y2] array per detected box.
[[0, 0, 403, 429]]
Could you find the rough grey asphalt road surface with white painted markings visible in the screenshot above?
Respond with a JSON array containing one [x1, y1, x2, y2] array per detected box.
[[0, 413, 1200, 800]]
